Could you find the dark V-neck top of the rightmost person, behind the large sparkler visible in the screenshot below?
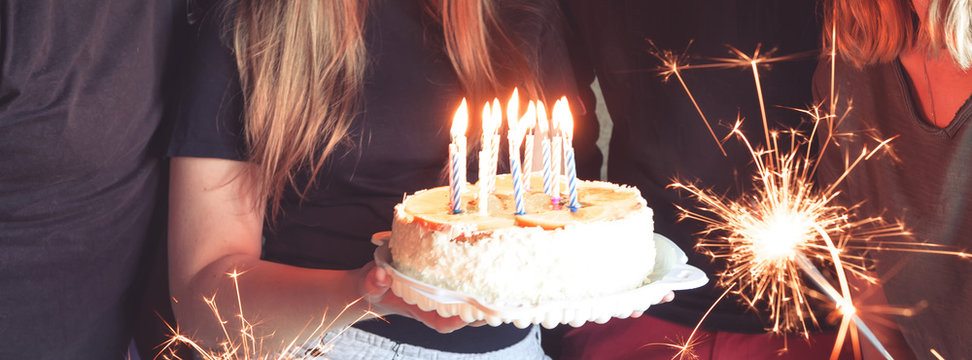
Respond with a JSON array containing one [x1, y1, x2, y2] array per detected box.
[[814, 61, 972, 359]]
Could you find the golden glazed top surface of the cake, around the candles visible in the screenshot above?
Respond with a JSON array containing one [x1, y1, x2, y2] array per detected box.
[[404, 174, 645, 230]]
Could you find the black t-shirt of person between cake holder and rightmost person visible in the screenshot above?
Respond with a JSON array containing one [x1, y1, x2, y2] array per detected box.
[[562, 0, 819, 332]]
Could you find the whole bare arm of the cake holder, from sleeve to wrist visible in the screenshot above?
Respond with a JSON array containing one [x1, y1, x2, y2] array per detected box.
[[168, 157, 382, 352]]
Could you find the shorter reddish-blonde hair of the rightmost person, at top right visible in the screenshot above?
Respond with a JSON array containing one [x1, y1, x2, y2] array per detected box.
[[823, 0, 972, 69]]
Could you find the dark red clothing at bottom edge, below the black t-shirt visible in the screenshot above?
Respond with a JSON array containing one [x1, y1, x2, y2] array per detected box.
[[562, 316, 854, 360]]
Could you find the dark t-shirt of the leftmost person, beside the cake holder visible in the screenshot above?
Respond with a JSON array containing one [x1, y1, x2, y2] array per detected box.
[[0, 0, 184, 359]]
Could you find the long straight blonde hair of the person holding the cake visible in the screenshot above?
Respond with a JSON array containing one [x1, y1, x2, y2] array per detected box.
[[232, 0, 539, 219]]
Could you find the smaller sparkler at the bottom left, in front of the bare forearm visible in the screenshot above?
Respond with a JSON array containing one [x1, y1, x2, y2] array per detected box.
[[155, 270, 382, 360]]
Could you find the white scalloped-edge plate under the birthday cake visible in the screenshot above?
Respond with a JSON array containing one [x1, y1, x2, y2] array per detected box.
[[371, 231, 709, 329]]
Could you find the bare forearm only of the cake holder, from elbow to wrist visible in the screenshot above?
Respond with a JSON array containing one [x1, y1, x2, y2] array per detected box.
[[173, 255, 370, 351]]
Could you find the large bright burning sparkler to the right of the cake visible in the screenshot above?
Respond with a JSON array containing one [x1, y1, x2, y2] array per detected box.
[[652, 43, 970, 359]]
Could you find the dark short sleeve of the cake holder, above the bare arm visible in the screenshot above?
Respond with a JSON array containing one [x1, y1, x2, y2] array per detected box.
[[168, 1, 246, 160]]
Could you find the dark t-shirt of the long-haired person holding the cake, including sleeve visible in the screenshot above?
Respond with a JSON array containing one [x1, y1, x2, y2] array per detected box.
[[169, 0, 600, 353]]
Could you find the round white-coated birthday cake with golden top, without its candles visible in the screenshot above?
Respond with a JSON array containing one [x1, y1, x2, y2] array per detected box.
[[388, 174, 655, 304]]
